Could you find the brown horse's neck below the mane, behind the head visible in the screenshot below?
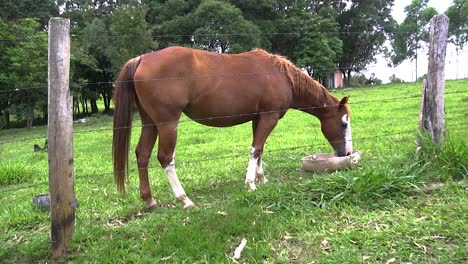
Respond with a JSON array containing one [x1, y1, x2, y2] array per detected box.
[[292, 80, 339, 119]]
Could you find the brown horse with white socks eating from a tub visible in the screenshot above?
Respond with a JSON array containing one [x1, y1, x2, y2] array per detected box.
[[113, 47, 352, 208]]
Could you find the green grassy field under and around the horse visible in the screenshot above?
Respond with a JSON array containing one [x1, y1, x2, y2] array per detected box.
[[0, 80, 468, 263]]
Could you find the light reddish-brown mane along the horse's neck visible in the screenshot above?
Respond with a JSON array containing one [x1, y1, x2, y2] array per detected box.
[[253, 49, 339, 108]]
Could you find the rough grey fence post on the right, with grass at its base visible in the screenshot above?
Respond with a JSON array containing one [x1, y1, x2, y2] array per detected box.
[[419, 14, 449, 147]]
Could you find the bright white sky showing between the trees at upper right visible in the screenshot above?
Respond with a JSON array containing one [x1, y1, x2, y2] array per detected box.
[[364, 0, 468, 83]]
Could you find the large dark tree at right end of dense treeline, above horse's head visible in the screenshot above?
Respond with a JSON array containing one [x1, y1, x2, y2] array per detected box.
[[332, 0, 396, 86]]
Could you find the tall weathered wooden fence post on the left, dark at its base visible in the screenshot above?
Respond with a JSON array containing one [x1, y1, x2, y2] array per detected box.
[[48, 17, 75, 262]]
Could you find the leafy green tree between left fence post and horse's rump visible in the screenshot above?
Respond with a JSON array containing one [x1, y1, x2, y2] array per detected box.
[[66, 0, 156, 113]]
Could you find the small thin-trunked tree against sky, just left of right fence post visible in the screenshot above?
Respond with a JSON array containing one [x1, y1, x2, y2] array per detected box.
[[391, 0, 437, 78]]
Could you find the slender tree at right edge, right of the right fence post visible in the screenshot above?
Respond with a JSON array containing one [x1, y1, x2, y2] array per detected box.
[[445, 0, 468, 79]]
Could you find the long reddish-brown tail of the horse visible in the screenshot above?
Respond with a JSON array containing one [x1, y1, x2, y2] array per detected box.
[[112, 57, 140, 192]]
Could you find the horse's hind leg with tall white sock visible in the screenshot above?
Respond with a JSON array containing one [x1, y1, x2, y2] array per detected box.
[[158, 123, 195, 208]]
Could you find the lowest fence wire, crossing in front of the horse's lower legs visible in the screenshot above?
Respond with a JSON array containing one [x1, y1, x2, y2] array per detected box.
[[0, 123, 466, 193]]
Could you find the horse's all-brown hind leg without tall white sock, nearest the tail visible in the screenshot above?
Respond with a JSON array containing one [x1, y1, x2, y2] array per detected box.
[[135, 108, 158, 209]]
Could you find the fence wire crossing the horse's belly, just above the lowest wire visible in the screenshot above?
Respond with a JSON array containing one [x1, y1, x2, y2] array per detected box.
[[0, 90, 468, 145]]
